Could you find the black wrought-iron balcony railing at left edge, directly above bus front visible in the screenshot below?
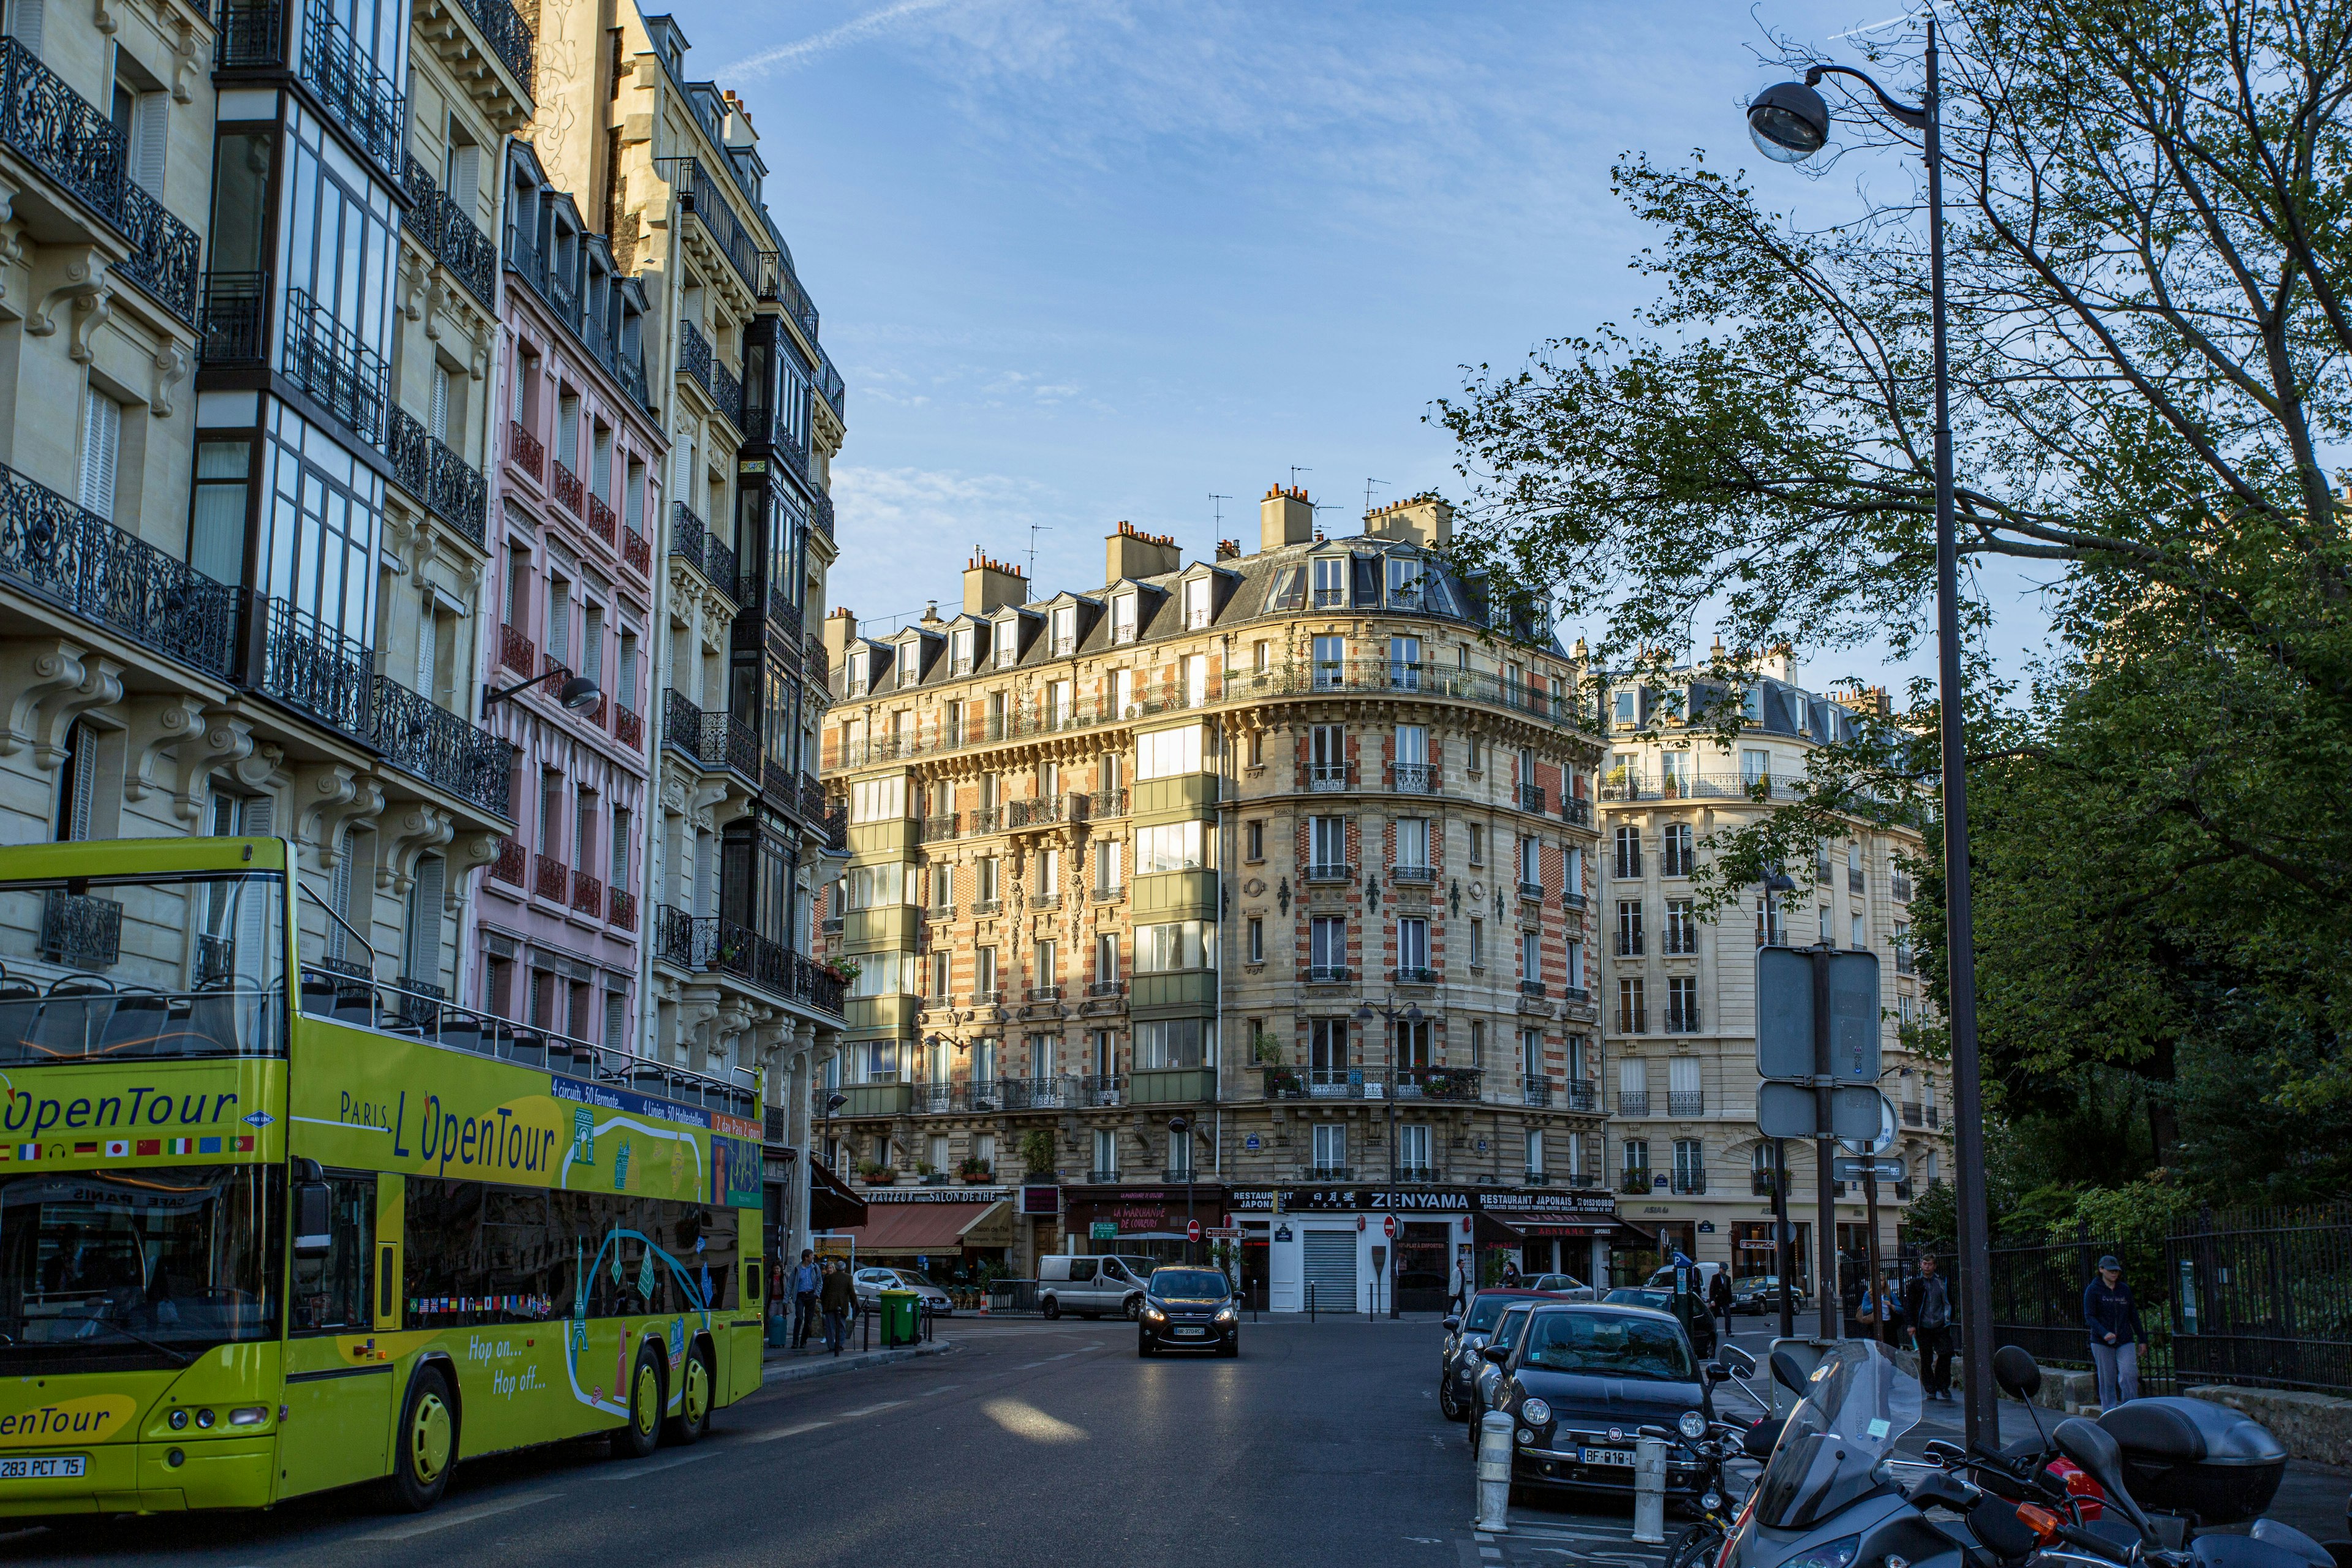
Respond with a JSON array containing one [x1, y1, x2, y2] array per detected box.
[[0, 466, 238, 679]]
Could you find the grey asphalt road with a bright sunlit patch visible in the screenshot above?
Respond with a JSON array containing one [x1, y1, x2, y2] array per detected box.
[[0, 1319, 1477, 1568]]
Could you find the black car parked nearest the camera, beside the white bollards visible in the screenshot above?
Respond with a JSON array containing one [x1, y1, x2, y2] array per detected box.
[[1496, 1302, 1722, 1500]]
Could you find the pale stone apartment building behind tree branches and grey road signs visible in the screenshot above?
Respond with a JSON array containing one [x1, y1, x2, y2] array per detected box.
[[1597, 651, 1950, 1284]]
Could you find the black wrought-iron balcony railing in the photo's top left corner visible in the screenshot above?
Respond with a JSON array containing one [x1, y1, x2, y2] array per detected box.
[[0, 37, 202, 322]]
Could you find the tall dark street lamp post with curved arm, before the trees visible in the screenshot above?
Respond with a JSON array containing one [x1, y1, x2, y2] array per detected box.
[[1747, 19, 1999, 1444]]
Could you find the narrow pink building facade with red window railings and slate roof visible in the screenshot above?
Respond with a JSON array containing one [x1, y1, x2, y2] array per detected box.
[[468, 143, 668, 1049]]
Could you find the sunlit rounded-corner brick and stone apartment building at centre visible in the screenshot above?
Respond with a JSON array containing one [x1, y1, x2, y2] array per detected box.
[[821, 489, 1616, 1310]]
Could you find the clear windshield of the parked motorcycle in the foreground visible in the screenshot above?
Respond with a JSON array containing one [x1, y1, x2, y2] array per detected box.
[[1757, 1340, 1919, 1531]]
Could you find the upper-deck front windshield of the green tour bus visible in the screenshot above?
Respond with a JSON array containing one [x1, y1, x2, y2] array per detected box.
[[0, 872, 285, 1067]]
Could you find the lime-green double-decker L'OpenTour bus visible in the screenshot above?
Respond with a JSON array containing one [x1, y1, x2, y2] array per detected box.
[[0, 839, 762, 1517]]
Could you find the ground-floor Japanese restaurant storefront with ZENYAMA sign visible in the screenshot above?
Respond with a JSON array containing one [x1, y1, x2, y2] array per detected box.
[[1230, 1187, 1621, 1312]]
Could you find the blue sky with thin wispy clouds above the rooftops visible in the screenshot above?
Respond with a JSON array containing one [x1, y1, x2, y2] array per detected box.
[[677, 0, 2060, 682]]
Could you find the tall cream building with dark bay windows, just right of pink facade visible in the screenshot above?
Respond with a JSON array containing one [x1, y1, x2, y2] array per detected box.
[[518, 0, 845, 1246]]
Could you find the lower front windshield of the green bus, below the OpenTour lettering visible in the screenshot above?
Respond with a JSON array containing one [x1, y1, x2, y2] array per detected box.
[[0, 1166, 285, 1375]]
